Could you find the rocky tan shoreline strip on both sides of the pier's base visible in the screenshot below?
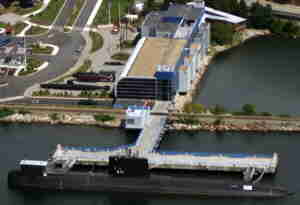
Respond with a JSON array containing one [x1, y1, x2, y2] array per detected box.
[[0, 110, 300, 132]]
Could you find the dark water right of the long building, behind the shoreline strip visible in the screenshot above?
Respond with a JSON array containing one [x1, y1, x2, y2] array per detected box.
[[194, 36, 300, 115]]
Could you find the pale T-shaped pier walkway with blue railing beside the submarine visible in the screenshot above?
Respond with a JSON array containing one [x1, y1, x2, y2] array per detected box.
[[52, 102, 278, 174]]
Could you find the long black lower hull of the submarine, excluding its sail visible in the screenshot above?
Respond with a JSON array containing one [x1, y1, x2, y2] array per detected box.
[[8, 170, 289, 198]]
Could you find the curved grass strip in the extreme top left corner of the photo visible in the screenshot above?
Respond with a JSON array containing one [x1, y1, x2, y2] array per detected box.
[[0, 1, 43, 15]]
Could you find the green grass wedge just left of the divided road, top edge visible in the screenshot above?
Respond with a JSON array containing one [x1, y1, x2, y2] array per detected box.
[[31, 0, 65, 25]]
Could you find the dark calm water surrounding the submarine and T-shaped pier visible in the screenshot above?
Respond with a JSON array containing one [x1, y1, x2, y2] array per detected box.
[[0, 125, 300, 205]]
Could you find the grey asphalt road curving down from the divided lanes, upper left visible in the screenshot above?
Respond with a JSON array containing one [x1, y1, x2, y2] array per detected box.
[[0, 0, 96, 99]]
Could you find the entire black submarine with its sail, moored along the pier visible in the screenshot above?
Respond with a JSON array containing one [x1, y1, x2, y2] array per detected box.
[[8, 156, 291, 198]]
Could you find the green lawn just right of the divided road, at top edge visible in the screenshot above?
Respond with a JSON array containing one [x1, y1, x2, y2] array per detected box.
[[93, 0, 134, 26]]
